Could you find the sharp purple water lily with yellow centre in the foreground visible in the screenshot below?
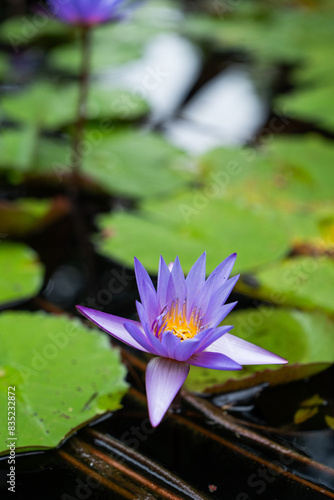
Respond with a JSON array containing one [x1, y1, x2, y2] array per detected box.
[[77, 254, 287, 427]]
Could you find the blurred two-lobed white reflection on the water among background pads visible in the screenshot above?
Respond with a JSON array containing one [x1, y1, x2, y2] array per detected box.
[[103, 33, 267, 154]]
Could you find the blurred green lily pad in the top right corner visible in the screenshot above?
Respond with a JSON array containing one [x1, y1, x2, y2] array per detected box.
[[184, 2, 334, 64]]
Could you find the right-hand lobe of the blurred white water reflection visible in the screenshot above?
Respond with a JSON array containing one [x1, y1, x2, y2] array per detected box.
[[166, 65, 266, 154]]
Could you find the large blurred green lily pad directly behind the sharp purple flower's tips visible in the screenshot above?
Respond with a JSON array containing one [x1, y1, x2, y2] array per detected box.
[[97, 191, 289, 273]]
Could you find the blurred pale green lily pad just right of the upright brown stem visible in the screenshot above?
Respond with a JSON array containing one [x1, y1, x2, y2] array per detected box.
[[83, 129, 189, 197]]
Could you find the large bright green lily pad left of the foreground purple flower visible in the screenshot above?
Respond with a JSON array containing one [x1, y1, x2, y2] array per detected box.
[[0, 312, 128, 454]]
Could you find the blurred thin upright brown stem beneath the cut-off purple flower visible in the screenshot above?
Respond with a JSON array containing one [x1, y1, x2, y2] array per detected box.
[[72, 26, 91, 179]]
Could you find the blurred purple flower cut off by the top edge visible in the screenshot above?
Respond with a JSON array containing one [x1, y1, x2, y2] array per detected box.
[[48, 0, 134, 26]]
